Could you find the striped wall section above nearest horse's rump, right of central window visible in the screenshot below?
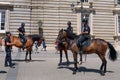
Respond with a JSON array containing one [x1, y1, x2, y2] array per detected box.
[[93, 0, 115, 43]]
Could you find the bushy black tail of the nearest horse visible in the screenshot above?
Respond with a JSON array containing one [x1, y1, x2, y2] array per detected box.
[[107, 42, 117, 61]]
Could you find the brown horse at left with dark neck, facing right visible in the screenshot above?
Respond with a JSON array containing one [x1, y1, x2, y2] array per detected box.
[[10, 35, 44, 61]]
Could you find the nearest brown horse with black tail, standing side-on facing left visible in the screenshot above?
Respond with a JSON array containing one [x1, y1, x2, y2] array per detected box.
[[59, 29, 117, 75]]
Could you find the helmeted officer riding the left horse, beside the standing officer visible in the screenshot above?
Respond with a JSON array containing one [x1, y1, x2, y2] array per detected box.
[[18, 23, 27, 49]]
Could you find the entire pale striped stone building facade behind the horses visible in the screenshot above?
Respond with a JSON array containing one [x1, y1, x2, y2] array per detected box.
[[0, 0, 120, 46]]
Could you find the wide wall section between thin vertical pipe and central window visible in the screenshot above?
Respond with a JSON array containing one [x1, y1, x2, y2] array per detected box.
[[29, 0, 77, 46]]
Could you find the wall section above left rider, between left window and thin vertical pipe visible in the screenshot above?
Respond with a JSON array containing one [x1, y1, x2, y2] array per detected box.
[[9, 0, 31, 35]]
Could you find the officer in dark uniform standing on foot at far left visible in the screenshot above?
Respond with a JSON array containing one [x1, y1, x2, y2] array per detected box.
[[5, 32, 13, 67]]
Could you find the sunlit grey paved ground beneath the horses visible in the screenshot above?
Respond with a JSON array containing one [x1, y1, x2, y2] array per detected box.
[[0, 47, 120, 80]]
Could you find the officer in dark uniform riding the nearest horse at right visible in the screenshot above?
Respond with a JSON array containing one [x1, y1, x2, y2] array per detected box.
[[78, 19, 90, 53]]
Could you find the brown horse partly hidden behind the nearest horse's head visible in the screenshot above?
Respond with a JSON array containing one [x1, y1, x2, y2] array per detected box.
[[56, 31, 69, 65]]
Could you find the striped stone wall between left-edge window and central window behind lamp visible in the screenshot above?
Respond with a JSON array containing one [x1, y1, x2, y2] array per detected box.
[[0, 0, 77, 46]]
